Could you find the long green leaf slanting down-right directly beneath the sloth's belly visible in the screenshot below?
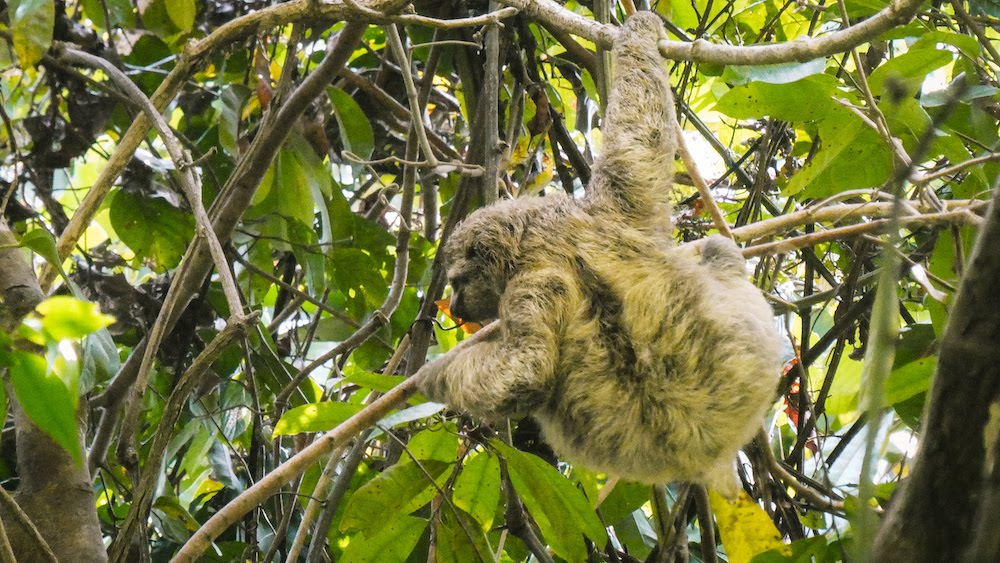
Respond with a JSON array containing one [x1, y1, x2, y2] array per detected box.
[[490, 439, 608, 561]]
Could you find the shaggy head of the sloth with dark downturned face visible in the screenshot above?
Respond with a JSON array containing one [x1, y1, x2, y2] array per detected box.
[[444, 198, 544, 321]]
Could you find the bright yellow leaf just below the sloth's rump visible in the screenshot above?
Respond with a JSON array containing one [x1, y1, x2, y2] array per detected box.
[[709, 491, 785, 561]]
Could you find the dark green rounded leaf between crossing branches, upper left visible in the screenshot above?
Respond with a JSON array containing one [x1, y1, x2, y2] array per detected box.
[[109, 190, 194, 272]]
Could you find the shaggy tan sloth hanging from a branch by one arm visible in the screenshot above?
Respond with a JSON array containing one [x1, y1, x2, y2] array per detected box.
[[416, 12, 781, 491]]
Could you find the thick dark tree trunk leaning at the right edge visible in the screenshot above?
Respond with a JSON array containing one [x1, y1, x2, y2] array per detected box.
[[870, 186, 1000, 563]]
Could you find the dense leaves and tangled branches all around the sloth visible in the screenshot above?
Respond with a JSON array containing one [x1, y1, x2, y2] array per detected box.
[[0, 0, 1000, 562]]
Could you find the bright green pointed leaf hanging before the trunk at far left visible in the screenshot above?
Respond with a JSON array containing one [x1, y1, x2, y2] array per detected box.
[[10, 351, 83, 464]]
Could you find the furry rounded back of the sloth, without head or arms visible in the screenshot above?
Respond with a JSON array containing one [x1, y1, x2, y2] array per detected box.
[[534, 227, 780, 485]]
